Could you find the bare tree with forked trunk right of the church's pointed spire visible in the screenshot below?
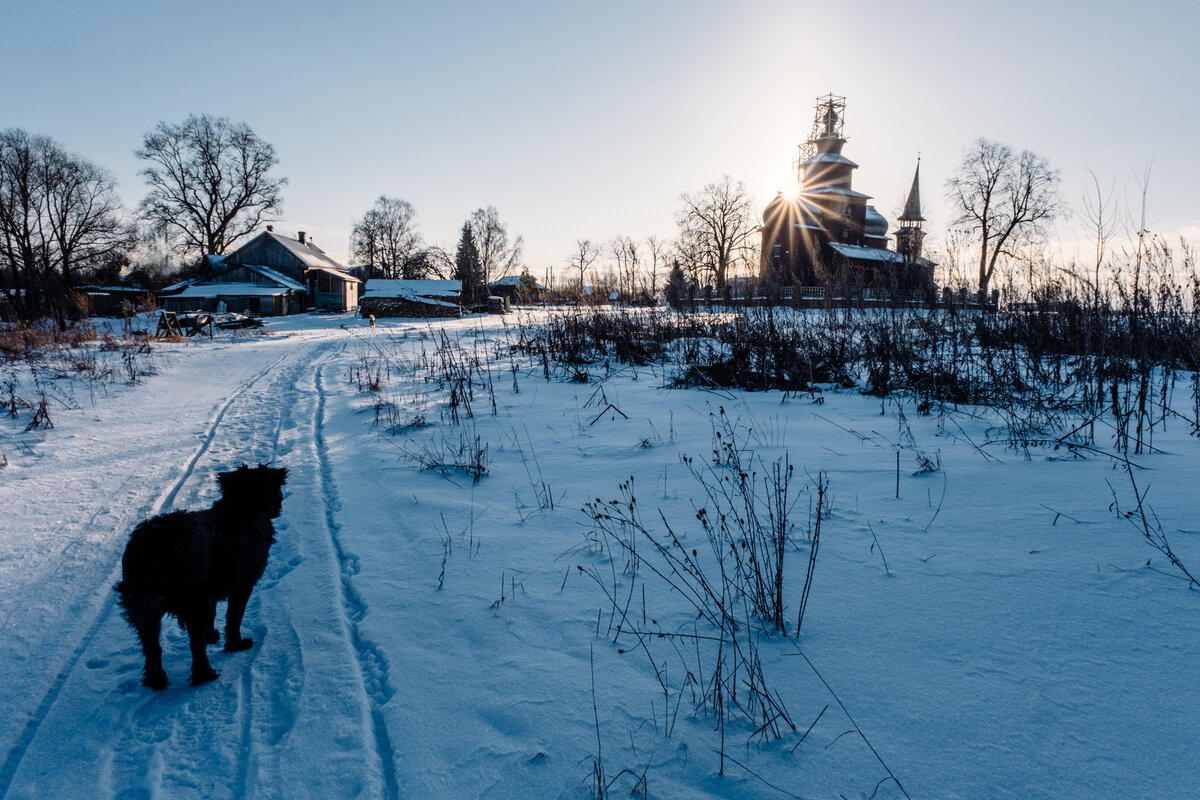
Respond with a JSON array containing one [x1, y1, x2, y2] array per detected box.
[[946, 138, 1063, 291]]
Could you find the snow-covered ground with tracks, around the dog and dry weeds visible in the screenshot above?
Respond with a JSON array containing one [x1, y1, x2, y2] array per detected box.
[[0, 315, 1200, 800]]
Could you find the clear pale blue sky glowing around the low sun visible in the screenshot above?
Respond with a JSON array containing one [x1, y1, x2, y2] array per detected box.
[[9, 0, 1200, 276]]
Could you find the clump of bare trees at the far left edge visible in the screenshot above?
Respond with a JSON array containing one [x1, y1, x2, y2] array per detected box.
[[0, 128, 134, 324]]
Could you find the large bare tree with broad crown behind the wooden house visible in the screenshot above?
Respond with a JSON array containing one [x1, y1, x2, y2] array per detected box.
[[134, 114, 287, 255]]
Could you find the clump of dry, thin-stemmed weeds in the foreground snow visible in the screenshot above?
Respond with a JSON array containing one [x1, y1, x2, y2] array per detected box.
[[577, 419, 827, 772]]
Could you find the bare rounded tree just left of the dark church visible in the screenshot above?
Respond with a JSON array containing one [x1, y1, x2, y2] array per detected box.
[[676, 175, 758, 288]]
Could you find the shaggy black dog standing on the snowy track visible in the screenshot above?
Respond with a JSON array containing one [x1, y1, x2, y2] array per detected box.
[[115, 464, 288, 688]]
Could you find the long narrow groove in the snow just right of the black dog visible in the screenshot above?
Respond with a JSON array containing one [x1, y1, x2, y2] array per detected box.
[[313, 365, 400, 800]]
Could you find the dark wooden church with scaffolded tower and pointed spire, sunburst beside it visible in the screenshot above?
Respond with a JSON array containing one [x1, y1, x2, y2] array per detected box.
[[761, 95, 934, 291]]
